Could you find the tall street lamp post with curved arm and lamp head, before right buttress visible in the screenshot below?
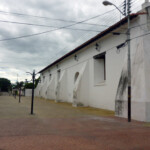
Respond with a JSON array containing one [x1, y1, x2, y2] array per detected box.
[[103, 0, 131, 122]]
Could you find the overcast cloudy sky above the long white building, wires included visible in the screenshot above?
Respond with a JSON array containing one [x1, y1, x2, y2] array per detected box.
[[0, 0, 144, 83]]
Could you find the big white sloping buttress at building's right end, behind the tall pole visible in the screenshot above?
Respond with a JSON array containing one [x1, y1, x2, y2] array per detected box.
[[116, 7, 150, 122]]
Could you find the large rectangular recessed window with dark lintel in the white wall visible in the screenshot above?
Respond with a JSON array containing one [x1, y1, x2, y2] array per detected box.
[[94, 52, 106, 84]]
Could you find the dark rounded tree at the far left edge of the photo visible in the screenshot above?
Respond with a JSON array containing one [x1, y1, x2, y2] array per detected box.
[[0, 78, 11, 92]]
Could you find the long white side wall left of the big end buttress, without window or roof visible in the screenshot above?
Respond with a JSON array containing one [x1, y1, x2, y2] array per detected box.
[[36, 24, 126, 110]]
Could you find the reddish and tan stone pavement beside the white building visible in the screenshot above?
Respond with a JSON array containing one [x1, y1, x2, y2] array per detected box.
[[0, 96, 150, 150]]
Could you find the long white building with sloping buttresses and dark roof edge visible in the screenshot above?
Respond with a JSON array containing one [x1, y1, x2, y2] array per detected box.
[[35, 2, 150, 121]]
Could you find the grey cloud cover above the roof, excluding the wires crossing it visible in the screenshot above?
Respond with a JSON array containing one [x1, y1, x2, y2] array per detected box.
[[0, 0, 142, 81]]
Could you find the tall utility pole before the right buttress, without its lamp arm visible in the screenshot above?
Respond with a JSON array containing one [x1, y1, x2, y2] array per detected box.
[[127, 0, 131, 122]]
